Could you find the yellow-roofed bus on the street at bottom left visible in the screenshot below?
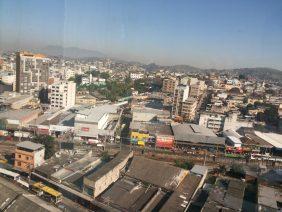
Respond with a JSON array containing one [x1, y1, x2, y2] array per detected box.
[[32, 182, 62, 204]]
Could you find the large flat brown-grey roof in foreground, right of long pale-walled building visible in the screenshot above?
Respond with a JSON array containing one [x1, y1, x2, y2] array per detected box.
[[126, 156, 188, 190]]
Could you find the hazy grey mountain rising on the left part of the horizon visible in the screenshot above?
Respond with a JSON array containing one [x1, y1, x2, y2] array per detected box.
[[37, 46, 106, 58]]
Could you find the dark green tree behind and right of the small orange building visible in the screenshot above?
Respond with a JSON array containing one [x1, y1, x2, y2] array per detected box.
[[32, 135, 55, 159]]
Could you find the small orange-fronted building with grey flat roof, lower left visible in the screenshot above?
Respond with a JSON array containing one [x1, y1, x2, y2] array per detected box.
[[14, 141, 45, 172]]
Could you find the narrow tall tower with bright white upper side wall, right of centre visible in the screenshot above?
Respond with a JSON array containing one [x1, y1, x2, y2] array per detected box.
[[172, 85, 189, 117]]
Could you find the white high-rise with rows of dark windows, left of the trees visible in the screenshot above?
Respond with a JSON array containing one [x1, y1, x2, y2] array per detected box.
[[50, 81, 76, 108]]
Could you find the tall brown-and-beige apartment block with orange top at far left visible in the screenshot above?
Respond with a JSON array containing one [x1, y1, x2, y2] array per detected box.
[[16, 52, 50, 96]]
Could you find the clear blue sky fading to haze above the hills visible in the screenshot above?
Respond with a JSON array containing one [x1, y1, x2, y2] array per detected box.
[[0, 0, 282, 70]]
